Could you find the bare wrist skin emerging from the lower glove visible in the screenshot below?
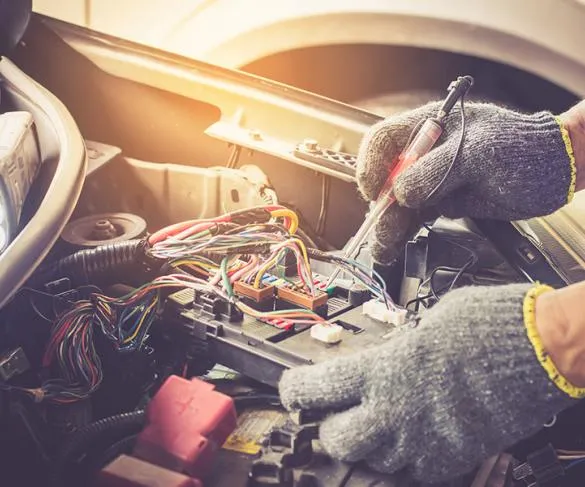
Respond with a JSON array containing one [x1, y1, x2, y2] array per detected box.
[[535, 282, 585, 388]]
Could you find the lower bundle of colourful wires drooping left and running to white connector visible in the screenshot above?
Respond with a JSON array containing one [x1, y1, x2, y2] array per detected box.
[[34, 266, 324, 402]]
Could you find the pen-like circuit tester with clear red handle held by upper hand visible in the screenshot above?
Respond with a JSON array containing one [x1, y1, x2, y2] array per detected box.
[[326, 76, 473, 288]]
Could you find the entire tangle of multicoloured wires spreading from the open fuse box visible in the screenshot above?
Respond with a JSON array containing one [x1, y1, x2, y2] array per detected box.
[[5, 205, 396, 403]]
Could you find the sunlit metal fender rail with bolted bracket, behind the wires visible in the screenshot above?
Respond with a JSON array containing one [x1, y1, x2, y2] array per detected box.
[[43, 18, 380, 182]]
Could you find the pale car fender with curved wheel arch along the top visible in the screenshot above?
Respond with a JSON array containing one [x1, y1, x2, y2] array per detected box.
[[35, 0, 585, 96]]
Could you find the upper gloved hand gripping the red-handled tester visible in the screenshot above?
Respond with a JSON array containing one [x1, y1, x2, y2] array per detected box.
[[357, 103, 576, 264]]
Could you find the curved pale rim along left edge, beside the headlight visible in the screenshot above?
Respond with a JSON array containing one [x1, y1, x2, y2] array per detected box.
[[0, 11, 87, 308]]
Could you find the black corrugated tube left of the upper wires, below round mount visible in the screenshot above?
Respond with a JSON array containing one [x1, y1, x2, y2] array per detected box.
[[31, 240, 144, 286]]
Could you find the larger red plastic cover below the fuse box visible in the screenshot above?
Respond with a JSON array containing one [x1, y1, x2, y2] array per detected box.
[[133, 376, 237, 478]]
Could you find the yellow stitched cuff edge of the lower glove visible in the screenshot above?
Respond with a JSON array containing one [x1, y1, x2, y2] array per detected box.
[[524, 284, 585, 399]]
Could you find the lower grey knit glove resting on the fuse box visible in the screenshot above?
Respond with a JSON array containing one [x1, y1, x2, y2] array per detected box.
[[279, 284, 577, 482]]
